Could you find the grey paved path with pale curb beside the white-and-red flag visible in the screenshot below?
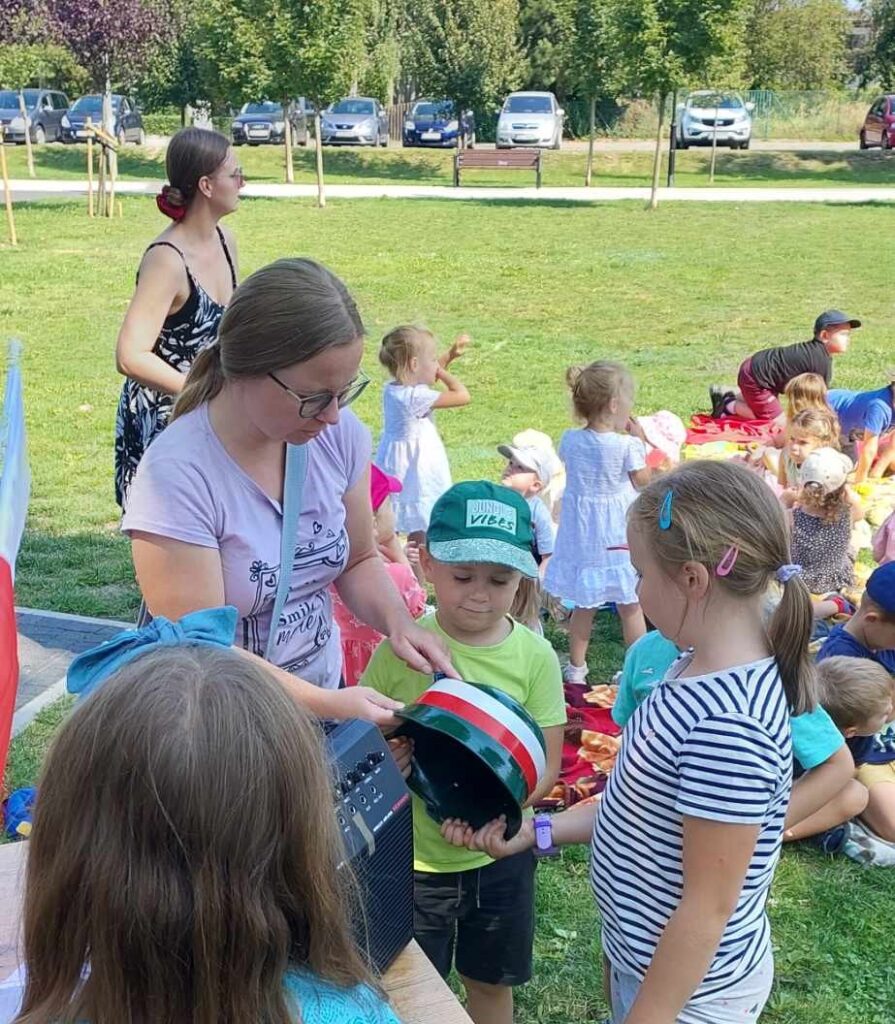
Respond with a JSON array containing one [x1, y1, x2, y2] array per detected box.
[[12, 608, 129, 735]]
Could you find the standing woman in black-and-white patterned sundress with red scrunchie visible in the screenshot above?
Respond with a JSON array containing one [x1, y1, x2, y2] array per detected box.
[[115, 128, 245, 509]]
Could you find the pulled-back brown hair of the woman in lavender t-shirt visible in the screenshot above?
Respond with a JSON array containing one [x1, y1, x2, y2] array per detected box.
[[171, 257, 364, 420]]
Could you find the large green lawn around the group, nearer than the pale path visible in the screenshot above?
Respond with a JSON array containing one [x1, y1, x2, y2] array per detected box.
[[0, 193, 895, 1024]]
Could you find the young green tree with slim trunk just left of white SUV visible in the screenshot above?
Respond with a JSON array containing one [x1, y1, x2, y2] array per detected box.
[[605, 0, 750, 210]]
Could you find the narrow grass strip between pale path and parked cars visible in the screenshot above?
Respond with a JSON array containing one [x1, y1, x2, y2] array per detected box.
[[6, 143, 895, 187]]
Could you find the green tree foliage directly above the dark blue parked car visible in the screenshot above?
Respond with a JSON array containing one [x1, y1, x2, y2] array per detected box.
[[408, 0, 523, 138]]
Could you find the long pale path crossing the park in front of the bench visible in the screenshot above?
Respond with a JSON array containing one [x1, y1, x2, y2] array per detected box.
[[10, 179, 895, 203]]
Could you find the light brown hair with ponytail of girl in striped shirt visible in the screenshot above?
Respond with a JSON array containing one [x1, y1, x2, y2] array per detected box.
[[629, 461, 817, 715]]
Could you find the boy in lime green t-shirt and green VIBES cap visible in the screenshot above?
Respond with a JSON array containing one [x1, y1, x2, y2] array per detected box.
[[360, 480, 565, 1024]]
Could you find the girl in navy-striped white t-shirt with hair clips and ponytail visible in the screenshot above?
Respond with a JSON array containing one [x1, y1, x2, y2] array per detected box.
[[443, 462, 815, 1024]]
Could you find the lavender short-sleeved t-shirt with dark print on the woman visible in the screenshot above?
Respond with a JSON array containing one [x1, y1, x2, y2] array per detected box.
[[122, 406, 371, 687]]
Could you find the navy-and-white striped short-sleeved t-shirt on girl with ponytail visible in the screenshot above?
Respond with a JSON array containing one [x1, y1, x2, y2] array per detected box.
[[591, 653, 793, 1002]]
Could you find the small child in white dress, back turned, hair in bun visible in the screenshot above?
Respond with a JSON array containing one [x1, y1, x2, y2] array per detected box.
[[544, 360, 650, 683]]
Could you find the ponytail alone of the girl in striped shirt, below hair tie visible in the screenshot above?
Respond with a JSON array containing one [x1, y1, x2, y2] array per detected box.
[[768, 566, 817, 715]]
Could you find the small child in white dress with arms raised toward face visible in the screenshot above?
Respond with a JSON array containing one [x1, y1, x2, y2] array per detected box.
[[375, 327, 469, 545]]
